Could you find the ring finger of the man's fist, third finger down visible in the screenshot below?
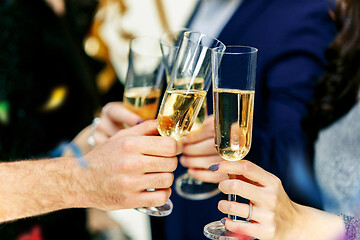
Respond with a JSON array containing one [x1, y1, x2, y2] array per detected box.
[[139, 173, 174, 190]]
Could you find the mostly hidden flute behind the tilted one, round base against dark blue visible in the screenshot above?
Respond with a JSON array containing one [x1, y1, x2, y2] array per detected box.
[[160, 28, 220, 200]]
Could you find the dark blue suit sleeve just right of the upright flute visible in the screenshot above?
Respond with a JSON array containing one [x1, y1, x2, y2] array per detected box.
[[245, 3, 336, 204]]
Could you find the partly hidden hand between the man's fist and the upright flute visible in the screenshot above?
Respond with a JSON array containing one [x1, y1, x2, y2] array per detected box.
[[180, 116, 228, 183]]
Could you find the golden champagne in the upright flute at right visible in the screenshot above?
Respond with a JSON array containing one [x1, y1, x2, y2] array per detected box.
[[214, 89, 255, 161]]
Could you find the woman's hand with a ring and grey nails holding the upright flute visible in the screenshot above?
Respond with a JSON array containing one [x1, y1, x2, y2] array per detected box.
[[212, 160, 344, 240]]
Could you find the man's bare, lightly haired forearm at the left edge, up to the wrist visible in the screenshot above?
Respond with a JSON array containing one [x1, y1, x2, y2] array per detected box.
[[0, 158, 89, 222]]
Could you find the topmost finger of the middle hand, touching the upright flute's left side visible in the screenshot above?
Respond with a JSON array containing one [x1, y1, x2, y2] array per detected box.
[[183, 116, 214, 144]]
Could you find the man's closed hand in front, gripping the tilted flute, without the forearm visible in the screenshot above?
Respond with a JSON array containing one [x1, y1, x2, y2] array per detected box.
[[83, 120, 182, 210]]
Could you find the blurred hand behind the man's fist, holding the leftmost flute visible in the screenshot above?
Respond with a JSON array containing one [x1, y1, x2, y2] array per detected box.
[[93, 102, 143, 144]]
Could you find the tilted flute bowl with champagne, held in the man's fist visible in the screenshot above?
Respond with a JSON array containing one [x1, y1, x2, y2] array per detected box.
[[158, 31, 225, 204]]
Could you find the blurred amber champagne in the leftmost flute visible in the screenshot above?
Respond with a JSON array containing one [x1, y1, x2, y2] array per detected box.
[[124, 87, 161, 120]]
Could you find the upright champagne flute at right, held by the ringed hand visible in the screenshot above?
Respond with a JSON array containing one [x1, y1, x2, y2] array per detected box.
[[204, 46, 258, 240]]
